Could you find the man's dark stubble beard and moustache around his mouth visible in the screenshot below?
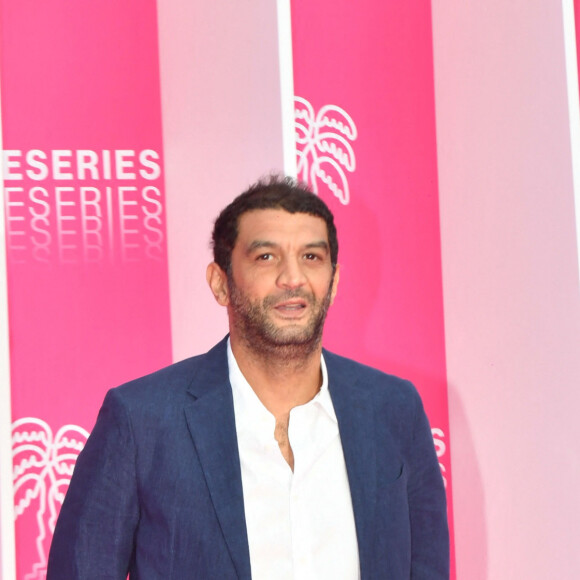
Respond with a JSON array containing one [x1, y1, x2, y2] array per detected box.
[[228, 275, 334, 363]]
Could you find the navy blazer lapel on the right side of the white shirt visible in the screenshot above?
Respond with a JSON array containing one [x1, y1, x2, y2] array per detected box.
[[324, 351, 377, 578]]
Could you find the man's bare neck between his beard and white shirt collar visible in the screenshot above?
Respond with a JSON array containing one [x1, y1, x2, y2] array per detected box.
[[230, 337, 322, 419]]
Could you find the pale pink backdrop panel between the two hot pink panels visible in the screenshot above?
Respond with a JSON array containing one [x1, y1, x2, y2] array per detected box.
[[158, 0, 283, 360]]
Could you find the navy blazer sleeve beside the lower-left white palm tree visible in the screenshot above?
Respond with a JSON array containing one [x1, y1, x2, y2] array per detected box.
[[46, 390, 139, 580]]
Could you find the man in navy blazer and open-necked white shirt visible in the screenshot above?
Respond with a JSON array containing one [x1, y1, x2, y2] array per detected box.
[[47, 178, 449, 580]]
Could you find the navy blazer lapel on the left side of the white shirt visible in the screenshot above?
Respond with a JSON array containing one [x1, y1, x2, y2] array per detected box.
[[185, 339, 251, 580]]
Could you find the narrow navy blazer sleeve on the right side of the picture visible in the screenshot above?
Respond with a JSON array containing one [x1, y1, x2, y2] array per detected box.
[[407, 395, 449, 580]]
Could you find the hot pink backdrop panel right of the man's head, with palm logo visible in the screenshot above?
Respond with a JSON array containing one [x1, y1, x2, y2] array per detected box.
[[292, 0, 453, 572]]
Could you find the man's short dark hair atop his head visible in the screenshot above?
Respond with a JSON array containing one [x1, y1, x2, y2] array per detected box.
[[212, 175, 338, 274]]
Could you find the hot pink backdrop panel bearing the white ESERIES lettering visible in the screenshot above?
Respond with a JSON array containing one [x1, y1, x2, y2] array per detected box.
[[1, 0, 171, 579]]
